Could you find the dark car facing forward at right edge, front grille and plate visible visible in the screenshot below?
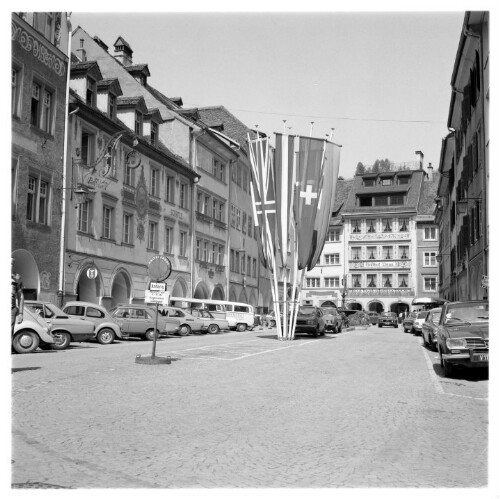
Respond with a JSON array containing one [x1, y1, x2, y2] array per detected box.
[[436, 301, 489, 376]]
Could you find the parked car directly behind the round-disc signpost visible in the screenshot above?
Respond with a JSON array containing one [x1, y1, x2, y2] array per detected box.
[[109, 305, 180, 340]]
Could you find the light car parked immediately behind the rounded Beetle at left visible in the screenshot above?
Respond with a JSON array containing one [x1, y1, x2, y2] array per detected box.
[[24, 300, 96, 350]]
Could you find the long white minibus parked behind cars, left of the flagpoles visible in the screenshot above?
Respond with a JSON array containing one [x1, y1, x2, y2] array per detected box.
[[170, 296, 255, 331]]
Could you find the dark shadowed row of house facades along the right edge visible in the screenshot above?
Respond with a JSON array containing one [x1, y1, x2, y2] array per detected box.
[[435, 11, 489, 300]]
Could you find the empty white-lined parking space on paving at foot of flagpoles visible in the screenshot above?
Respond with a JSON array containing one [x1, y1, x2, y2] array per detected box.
[[159, 339, 315, 361]]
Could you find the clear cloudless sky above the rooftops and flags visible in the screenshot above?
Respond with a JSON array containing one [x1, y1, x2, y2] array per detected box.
[[71, 10, 464, 177]]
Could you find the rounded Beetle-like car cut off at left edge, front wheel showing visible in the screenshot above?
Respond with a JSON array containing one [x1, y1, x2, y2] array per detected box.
[[12, 306, 55, 353]]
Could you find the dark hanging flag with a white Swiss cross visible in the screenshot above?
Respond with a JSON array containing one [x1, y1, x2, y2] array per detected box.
[[294, 137, 326, 270]]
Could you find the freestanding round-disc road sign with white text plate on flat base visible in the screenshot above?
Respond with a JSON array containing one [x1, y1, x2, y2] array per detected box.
[[135, 255, 172, 364]]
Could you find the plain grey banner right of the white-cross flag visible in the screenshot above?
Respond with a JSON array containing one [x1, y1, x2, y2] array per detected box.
[[307, 142, 340, 270]]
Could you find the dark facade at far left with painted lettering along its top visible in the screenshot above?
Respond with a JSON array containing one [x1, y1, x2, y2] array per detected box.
[[11, 12, 69, 302]]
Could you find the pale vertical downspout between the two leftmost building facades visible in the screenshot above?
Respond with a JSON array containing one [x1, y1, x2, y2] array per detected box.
[[57, 13, 73, 307]]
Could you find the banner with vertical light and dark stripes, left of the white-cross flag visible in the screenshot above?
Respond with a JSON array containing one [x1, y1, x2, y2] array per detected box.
[[274, 133, 295, 264]]
